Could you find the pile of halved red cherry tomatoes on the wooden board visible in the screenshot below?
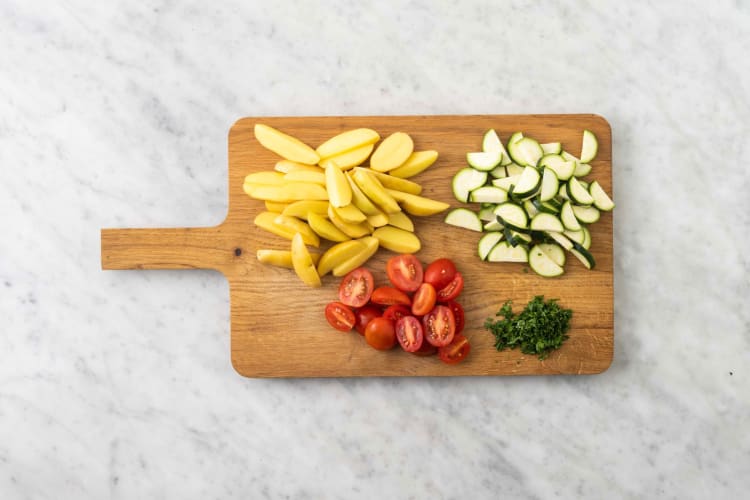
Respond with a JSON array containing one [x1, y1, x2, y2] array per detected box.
[[325, 254, 471, 364]]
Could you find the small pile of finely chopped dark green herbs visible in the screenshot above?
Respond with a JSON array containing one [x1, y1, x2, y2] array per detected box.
[[484, 295, 573, 359]]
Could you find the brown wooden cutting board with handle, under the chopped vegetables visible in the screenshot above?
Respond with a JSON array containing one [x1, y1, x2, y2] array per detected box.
[[101, 114, 614, 377]]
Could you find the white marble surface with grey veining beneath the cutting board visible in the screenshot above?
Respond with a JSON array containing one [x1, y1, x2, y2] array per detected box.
[[0, 0, 750, 500]]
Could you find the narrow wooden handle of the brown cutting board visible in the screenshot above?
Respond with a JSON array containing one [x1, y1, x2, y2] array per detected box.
[[101, 226, 234, 271]]
